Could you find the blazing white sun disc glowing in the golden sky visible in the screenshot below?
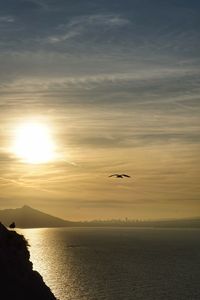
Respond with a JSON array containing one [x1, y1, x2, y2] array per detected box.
[[13, 122, 55, 164]]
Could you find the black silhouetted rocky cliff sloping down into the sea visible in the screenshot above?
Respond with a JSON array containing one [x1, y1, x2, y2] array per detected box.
[[0, 223, 56, 300]]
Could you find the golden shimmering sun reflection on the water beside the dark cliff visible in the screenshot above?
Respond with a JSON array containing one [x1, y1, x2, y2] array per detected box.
[[17, 228, 84, 300]]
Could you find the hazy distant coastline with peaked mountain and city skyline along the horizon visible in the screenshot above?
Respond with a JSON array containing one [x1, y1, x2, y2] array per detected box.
[[0, 205, 200, 228]]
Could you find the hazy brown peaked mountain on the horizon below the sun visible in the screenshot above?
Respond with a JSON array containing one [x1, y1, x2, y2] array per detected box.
[[0, 205, 73, 228]]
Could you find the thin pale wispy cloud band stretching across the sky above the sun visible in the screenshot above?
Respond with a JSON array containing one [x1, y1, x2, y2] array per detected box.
[[1, 65, 199, 92]]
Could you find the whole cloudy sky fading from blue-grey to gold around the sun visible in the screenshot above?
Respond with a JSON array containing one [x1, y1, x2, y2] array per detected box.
[[0, 0, 200, 220]]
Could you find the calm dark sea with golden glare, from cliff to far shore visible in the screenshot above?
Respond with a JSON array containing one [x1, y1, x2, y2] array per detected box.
[[17, 228, 200, 300]]
